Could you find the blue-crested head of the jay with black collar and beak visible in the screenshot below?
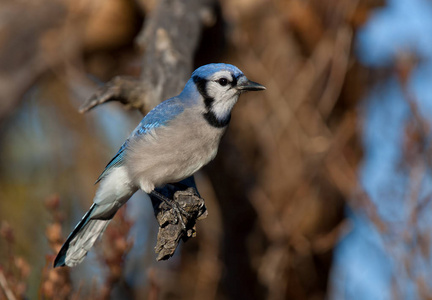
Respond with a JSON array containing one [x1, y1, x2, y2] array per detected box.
[[192, 64, 265, 127]]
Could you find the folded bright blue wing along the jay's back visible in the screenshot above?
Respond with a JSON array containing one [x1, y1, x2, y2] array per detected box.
[[96, 97, 184, 183]]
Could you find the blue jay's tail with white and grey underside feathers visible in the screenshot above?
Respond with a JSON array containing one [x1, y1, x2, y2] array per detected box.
[[54, 204, 111, 268]]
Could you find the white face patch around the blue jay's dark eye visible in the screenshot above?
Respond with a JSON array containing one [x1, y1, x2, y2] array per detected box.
[[206, 70, 240, 119]]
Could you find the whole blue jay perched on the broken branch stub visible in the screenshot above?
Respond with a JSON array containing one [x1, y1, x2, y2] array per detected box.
[[54, 63, 266, 267]]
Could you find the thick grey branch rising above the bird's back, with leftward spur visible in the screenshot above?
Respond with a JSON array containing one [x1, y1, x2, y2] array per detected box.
[[80, 0, 215, 114]]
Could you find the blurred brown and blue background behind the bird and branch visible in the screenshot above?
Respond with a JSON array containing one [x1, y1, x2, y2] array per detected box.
[[0, 0, 432, 300]]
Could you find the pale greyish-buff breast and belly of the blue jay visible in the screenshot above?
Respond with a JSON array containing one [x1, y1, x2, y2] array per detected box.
[[125, 111, 225, 193]]
